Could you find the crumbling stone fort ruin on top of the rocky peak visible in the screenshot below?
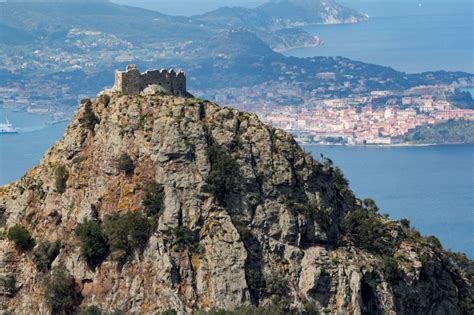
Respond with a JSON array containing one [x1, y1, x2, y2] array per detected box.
[[112, 65, 189, 96]]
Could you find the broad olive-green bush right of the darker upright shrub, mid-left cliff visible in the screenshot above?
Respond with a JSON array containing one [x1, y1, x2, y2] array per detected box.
[[103, 212, 152, 263]]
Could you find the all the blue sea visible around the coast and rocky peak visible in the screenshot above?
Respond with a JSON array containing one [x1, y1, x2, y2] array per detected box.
[[0, 0, 474, 258]]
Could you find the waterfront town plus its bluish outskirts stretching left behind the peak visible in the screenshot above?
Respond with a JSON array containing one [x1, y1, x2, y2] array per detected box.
[[196, 83, 474, 145]]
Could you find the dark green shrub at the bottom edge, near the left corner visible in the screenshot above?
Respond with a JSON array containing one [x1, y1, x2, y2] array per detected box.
[[44, 267, 82, 314]]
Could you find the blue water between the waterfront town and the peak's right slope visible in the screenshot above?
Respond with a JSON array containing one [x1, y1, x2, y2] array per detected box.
[[305, 145, 474, 258]]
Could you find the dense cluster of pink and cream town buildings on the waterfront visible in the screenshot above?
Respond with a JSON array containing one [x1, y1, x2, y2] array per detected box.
[[259, 91, 474, 145]]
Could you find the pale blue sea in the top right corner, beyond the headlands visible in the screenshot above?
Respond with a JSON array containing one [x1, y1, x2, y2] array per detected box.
[[286, 0, 474, 73]]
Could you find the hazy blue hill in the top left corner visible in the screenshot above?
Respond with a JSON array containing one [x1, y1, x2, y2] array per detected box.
[[0, 1, 196, 45]]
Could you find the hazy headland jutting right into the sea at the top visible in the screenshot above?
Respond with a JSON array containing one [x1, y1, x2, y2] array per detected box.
[[194, 0, 367, 50]]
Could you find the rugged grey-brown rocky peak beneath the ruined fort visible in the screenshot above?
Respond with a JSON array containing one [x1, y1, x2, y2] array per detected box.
[[0, 92, 473, 314]]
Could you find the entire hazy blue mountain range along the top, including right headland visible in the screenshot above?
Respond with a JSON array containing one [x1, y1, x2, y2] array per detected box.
[[0, 0, 361, 49]]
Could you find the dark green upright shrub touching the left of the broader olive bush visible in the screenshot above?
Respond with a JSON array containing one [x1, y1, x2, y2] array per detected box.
[[76, 221, 109, 268]]
